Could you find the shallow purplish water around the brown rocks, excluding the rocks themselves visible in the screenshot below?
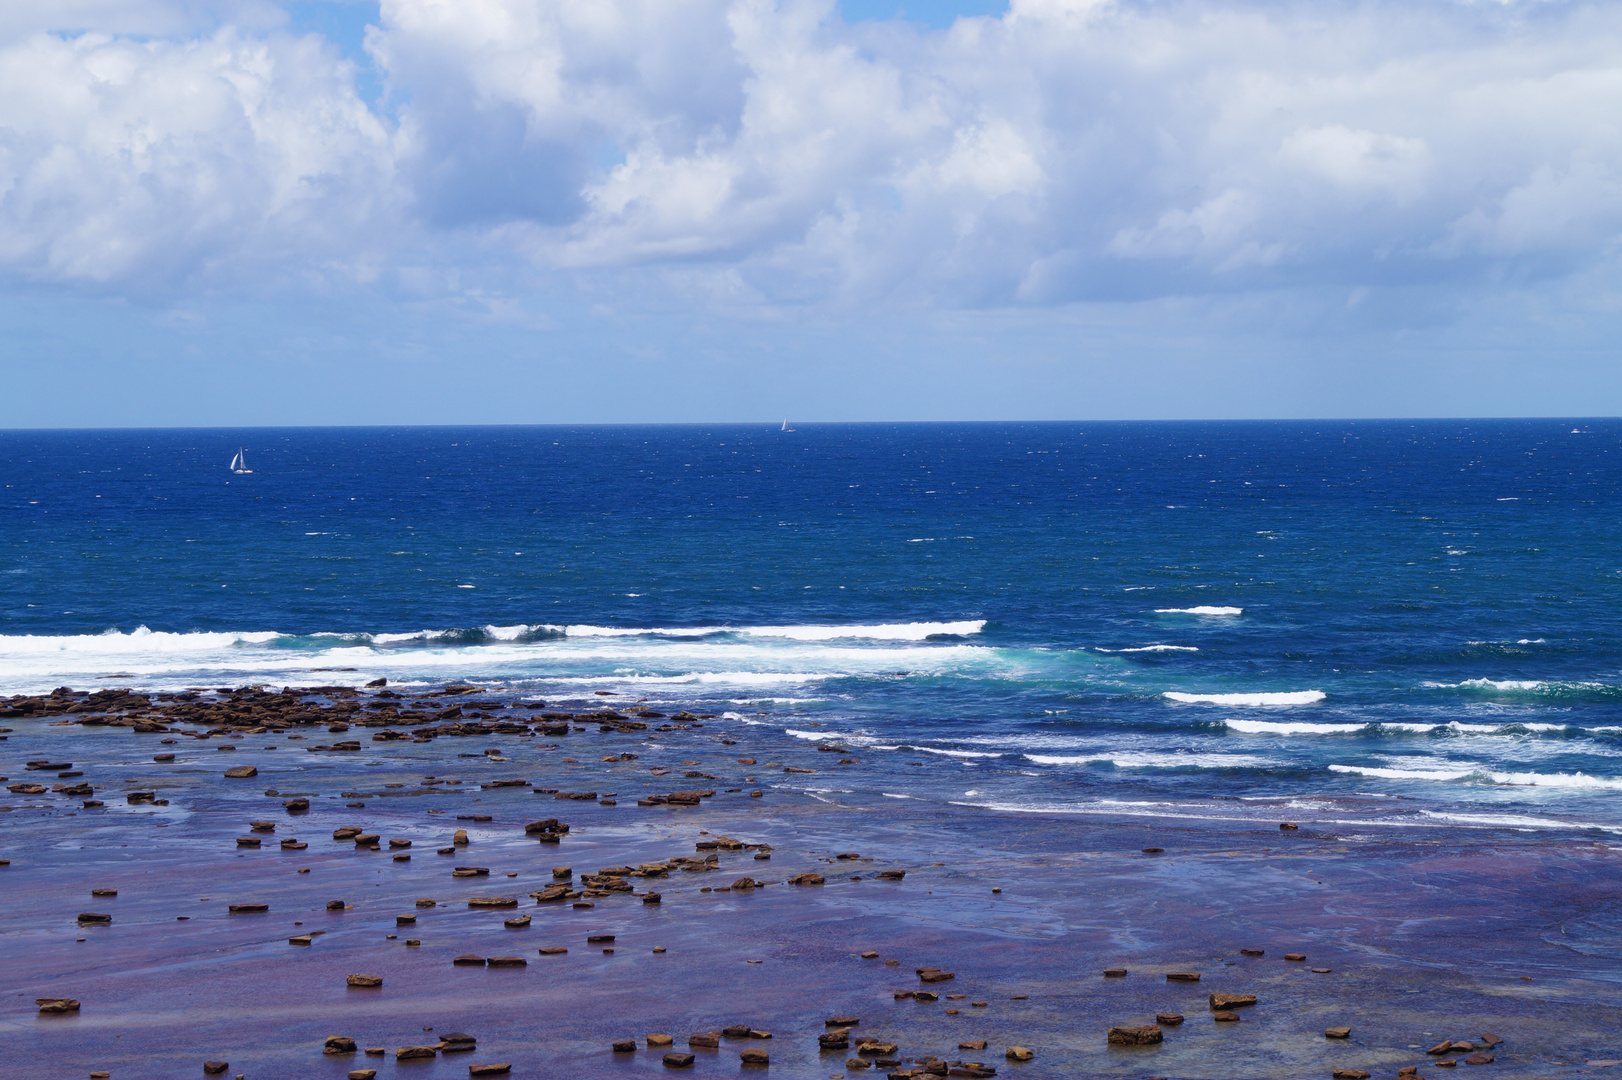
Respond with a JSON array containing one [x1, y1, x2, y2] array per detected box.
[[0, 703, 1622, 1078]]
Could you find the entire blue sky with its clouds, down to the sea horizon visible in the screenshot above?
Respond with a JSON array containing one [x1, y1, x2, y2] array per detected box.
[[0, 0, 1622, 426]]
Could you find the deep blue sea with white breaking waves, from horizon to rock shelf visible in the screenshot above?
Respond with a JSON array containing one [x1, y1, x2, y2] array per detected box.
[[0, 420, 1622, 842]]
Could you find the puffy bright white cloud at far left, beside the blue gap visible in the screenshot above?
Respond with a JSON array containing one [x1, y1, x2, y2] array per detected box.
[[0, 29, 394, 292]]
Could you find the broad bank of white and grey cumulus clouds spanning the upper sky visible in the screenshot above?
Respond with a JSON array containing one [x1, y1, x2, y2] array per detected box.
[[0, 0, 1622, 306]]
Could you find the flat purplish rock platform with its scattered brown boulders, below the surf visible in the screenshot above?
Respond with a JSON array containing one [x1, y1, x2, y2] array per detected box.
[[0, 683, 1622, 1080]]
